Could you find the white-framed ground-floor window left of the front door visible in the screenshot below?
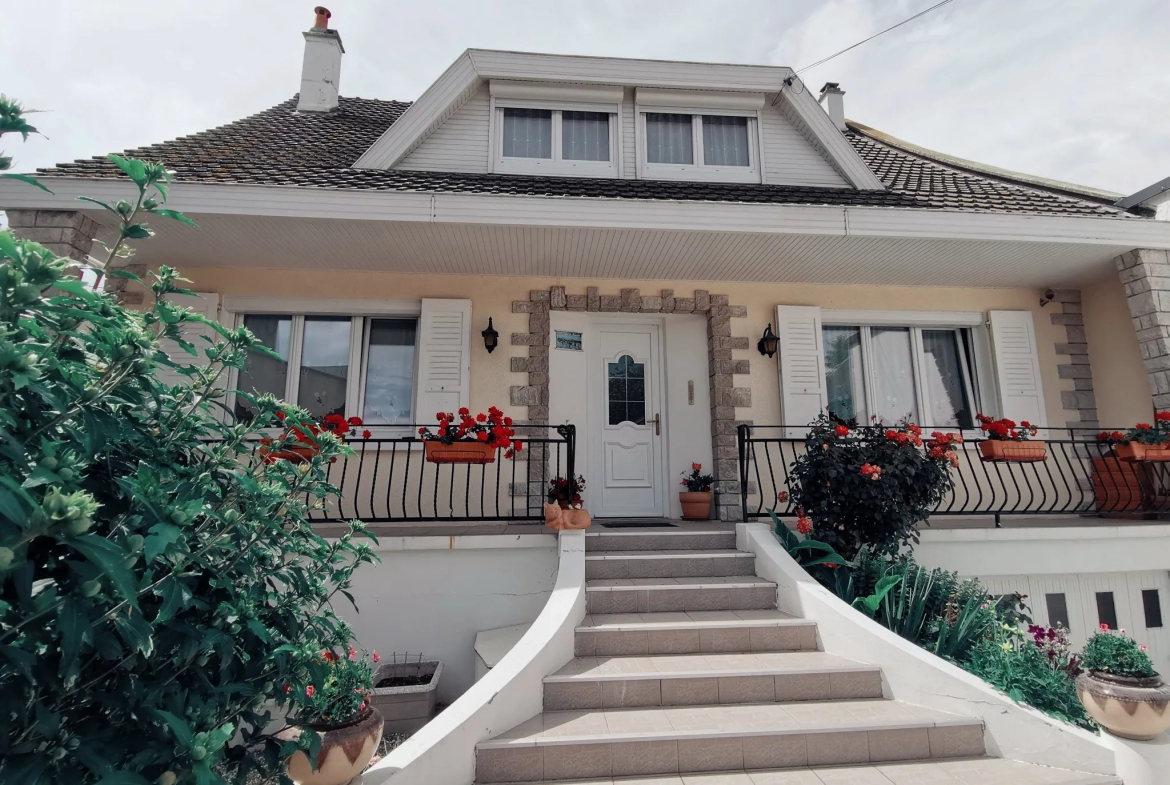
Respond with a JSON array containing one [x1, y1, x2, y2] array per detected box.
[[234, 314, 418, 426]]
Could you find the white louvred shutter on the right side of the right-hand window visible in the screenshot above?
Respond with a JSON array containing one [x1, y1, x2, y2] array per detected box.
[[987, 311, 1048, 428]]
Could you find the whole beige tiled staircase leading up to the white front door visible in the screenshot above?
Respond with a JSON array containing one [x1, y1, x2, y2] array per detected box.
[[476, 524, 1121, 785]]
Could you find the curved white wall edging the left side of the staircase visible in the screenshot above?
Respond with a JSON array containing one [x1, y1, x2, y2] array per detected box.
[[362, 531, 585, 785]]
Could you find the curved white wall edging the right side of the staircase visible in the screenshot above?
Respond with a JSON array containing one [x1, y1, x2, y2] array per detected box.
[[736, 523, 1113, 785]]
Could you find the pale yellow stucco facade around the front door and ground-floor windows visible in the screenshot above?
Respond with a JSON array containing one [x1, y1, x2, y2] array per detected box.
[[183, 267, 1095, 426]]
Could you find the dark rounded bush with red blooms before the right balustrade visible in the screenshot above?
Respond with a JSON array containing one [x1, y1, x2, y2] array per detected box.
[[789, 415, 962, 558]]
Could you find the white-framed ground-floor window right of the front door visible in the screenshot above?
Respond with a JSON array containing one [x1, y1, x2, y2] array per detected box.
[[821, 324, 978, 428]]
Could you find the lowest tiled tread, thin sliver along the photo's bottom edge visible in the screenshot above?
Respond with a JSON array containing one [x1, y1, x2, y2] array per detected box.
[[484, 758, 1122, 785]]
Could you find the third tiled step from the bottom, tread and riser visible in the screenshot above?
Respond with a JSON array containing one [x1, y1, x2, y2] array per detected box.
[[544, 652, 882, 711]]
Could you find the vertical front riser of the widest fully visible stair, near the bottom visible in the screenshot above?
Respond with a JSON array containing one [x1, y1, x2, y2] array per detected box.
[[475, 725, 986, 783]]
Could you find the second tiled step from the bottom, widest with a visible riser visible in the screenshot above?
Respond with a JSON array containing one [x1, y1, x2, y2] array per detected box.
[[476, 701, 986, 783]]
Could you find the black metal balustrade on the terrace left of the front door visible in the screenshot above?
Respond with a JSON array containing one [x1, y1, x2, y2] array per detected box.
[[253, 425, 577, 523]]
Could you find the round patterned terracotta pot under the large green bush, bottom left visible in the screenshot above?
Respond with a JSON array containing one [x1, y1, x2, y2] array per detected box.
[[277, 707, 383, 785]]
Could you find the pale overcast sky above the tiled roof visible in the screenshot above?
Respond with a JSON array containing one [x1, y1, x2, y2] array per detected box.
[[0, 0, 1170, 193]]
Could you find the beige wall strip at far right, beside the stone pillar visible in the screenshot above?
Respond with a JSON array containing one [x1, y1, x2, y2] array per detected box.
[[1081, 274, 1152, 428]]
